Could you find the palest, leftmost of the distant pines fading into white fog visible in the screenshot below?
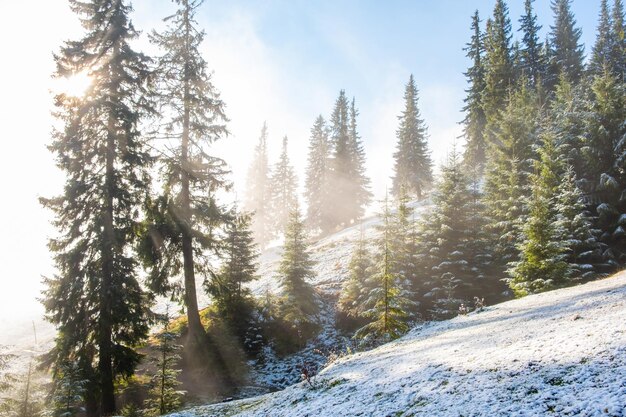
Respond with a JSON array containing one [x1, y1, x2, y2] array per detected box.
[[245, 123, 274, 248]]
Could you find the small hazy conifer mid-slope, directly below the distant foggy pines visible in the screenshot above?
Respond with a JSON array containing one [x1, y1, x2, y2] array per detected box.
[[278, 206, 319, 337]]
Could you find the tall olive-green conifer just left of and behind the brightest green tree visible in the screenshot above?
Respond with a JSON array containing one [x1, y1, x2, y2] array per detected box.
[[484, 82, 539, 273]]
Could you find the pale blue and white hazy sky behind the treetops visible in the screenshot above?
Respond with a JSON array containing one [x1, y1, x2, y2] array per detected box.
[[0, 0, 600, 323]]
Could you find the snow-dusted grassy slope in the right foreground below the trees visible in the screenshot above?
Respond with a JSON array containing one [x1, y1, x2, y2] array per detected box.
[[166, 272, 626, 417]]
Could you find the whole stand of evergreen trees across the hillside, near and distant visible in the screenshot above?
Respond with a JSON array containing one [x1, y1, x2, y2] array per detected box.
[[0, 0, 626, 416]]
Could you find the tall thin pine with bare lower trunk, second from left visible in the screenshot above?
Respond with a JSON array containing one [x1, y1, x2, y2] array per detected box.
[[145, 0, 229, 355]]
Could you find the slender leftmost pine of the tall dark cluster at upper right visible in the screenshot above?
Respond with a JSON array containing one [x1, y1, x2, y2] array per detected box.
[[463, 10, 487, 174]]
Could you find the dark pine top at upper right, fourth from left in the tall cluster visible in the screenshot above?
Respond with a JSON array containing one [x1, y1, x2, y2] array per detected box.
[[546, 0, 584, 87]]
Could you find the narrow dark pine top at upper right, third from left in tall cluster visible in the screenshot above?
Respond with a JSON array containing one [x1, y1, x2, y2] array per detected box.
[[519, 0, 545, 86]]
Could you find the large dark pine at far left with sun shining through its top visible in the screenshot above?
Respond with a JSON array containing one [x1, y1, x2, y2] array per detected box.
[[41, 0, 151, 416]]
